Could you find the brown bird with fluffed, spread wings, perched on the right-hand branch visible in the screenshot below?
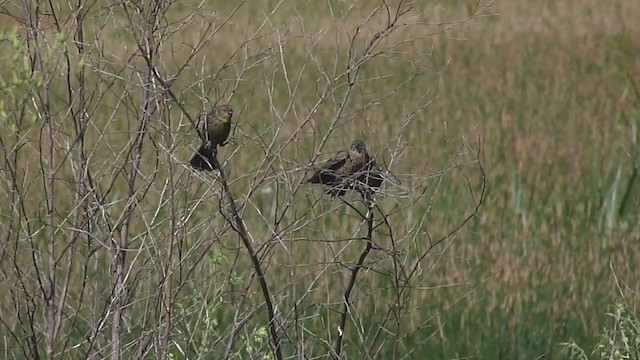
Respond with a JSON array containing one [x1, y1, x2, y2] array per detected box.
[[307, 139, 369, 197]]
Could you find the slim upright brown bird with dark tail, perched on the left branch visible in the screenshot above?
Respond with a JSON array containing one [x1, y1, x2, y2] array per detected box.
[[189, 104, 233, 171]]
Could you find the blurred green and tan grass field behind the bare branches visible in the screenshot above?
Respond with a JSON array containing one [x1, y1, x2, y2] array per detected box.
[[0, 0, 640, 359]]
